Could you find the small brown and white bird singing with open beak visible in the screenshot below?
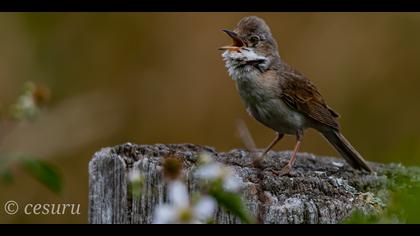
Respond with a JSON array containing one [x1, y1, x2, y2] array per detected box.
[[220, 16, 372, 174]]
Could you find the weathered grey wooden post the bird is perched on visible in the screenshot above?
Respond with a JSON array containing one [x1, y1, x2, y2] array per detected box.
[[89, 143, 420, 224]]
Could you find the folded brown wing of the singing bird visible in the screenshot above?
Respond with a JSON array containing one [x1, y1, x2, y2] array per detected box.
[[280, 65, 339, 129]]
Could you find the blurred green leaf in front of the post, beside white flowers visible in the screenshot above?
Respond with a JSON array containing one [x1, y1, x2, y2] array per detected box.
[[209, 182, 255, 224]]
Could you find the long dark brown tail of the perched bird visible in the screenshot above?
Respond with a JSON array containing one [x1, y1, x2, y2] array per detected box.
[[322, 129, 373, 172]]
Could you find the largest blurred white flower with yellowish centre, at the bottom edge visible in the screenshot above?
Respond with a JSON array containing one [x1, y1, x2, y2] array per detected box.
[[153, 181, 216, 224]]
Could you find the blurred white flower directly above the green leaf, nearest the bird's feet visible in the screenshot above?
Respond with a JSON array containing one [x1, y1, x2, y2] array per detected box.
[[195, 155, 242, 192]]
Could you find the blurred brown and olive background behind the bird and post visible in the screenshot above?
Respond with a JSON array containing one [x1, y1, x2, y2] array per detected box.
[[0, 13, 420, 223]]
